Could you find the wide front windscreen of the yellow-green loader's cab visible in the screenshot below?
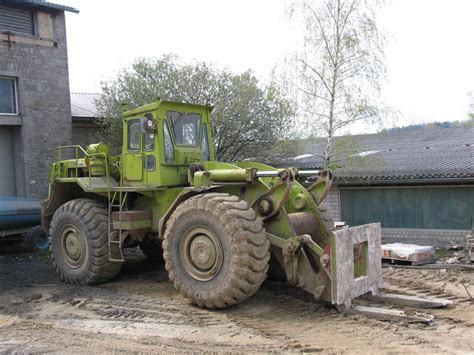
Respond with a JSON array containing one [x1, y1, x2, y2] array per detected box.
[[167, 111, 201, 146]]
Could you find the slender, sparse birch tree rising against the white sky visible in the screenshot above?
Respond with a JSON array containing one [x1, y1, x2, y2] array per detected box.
[[285, 0, 385, 166]]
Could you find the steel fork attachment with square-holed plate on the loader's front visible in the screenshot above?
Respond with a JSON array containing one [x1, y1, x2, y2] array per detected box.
[[251, 169, 452, 323]]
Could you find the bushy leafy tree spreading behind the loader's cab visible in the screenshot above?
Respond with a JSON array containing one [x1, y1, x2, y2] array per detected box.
[[97, 55, 293, 161]]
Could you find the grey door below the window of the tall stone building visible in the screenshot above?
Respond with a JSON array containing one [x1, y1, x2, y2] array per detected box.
[[0, 126, 16, 196]]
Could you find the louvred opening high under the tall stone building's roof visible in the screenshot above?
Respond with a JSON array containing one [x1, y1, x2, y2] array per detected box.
[[0, 6, 35, 36]]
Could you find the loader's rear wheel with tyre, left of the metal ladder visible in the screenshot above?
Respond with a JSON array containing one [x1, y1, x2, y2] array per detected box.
[[51, 198, 121, 285]]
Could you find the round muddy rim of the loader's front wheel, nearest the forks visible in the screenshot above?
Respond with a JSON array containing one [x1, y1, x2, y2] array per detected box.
[[179, 226, 224, 281]]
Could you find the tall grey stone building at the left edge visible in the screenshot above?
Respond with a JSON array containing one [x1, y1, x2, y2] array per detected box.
[[0, 0, 77, 198]]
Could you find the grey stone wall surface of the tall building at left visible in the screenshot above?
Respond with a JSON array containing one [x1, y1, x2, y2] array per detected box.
[[0, 12, 71, 198]]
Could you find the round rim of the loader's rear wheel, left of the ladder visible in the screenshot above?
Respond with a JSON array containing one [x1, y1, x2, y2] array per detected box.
[[61, 224, 86, 269]]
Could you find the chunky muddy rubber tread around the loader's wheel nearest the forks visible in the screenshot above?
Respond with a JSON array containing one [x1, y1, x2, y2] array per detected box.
[[163, 193, 270, 308]]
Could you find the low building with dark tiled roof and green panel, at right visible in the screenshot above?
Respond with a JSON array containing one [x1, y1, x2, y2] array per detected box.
[[282, 127, 474, 246]]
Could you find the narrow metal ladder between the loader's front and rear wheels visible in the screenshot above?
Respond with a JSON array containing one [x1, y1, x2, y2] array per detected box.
[[108, 189, 128, 262]]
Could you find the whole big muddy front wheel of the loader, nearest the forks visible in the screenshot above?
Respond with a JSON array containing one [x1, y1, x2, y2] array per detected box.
[[163, 193, 270, 308]]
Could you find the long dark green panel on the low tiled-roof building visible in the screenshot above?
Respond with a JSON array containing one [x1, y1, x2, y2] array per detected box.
[[341, 185, 474, 230]]
